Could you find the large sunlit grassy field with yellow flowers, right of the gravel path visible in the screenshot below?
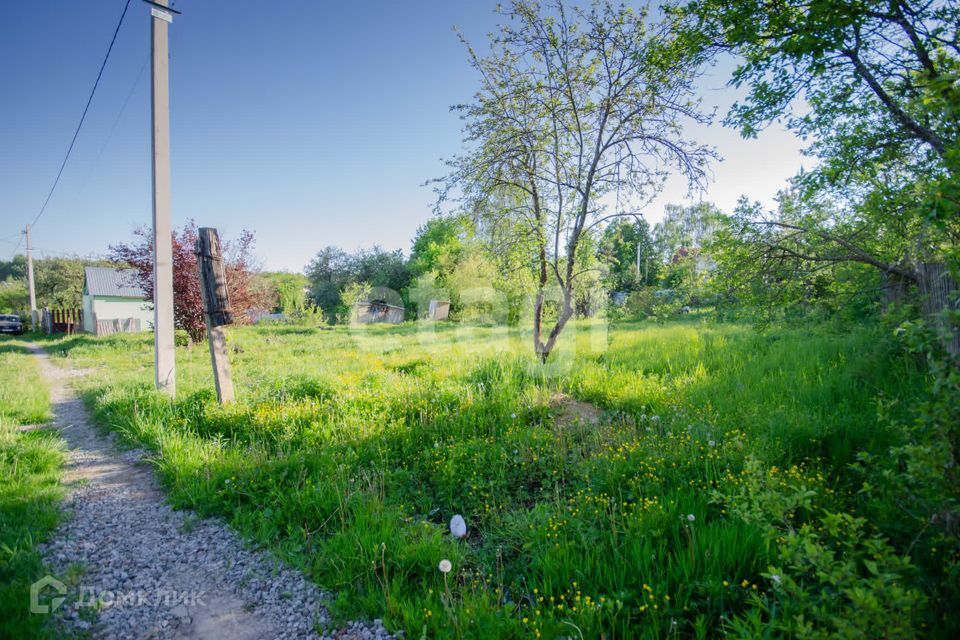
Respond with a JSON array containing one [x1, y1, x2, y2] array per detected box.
[[39, 319, 944, 638]]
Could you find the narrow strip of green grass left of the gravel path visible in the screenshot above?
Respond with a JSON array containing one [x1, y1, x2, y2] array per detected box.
[[0, 337, 63, 638]]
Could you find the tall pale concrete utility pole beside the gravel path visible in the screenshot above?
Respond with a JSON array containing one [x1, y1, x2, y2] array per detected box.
[[149, 0, 177, 396]]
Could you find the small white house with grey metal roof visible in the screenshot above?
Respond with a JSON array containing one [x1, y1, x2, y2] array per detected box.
[[83, 267, 153, 335]]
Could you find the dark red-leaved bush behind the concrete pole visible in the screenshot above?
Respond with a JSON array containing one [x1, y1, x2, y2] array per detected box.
[[110, 220, 273, 341]]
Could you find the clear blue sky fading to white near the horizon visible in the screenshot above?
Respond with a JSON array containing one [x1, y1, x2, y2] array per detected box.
[[0, 0, 810, 271]]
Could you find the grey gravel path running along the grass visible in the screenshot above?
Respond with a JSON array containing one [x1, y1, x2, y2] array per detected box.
[[31, 345, 390, 640]]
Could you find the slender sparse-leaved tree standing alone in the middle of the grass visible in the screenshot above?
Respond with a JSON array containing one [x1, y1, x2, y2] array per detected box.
[[439, 0, 711, 362]]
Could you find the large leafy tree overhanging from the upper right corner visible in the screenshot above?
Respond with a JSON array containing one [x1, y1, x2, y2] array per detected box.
[[673, 0, 960, 357]]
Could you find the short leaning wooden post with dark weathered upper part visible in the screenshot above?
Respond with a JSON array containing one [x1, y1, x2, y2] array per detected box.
[[196, 227, 233, 404]]
